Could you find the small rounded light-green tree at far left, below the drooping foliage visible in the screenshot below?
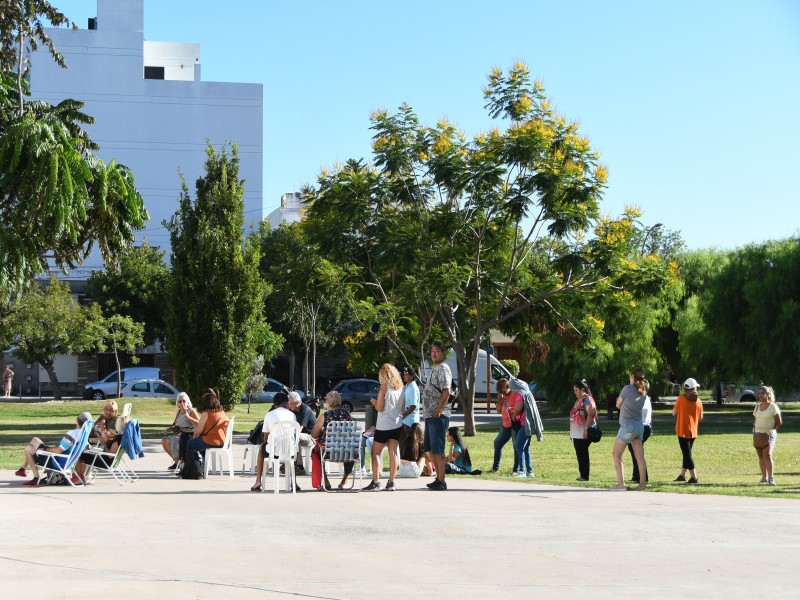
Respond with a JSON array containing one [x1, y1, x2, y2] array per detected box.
[[2, 276, 143, 399]]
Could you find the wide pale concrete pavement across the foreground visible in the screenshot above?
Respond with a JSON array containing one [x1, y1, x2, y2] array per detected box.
[[0, 439, 800, 600]]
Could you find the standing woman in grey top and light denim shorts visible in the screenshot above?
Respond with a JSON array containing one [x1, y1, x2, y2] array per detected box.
[[613, 369, 650, 490]]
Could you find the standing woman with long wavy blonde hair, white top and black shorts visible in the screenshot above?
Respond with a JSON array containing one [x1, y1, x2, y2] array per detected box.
[[364, 363, 404, 492]]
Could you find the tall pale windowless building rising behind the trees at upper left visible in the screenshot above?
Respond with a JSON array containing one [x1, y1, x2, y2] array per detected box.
[[30, 0, 263, 276]]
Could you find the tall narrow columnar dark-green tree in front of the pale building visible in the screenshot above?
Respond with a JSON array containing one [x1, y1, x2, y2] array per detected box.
[[164, 144, 282, 409]]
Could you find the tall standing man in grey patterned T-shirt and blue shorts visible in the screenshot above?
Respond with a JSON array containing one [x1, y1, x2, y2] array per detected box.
[[422, 342, 453, 492]]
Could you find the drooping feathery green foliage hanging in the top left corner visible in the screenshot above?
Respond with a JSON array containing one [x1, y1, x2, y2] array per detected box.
[[0, 0, 149, 305]]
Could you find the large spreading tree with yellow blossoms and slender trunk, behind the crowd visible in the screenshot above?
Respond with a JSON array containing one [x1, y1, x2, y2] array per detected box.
[[304, 63, 667, 435]]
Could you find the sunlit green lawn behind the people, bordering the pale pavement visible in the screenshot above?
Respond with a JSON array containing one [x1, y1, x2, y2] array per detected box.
[[0, 398, 800, 499]]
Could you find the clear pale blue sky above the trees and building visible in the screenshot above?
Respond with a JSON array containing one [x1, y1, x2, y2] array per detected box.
[[52, 0, 800, 249]]
